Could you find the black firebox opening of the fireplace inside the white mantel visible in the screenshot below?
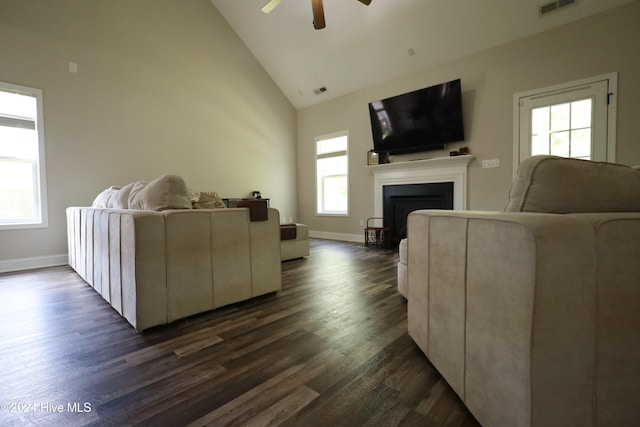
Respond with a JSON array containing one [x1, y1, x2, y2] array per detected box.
[[382, 182, 453, 247]]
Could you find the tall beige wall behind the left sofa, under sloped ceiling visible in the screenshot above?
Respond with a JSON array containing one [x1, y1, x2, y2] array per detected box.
[[0, 0, 297, 269]]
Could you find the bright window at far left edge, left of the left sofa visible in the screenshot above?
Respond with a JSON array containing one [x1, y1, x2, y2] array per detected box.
[[0, 82, 47, 229]]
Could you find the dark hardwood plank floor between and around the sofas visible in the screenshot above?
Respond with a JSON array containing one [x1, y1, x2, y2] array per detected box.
[[0, 240, 478, 427]]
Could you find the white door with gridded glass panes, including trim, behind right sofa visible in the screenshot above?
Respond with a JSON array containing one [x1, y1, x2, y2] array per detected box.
[[514, 74, 617, 174]]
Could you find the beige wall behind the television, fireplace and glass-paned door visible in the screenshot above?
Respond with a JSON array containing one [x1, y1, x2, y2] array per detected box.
[[298, 2, 640, 236]]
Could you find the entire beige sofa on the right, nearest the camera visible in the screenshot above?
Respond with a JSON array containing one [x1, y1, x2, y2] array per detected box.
[[407, 156, 640, 427]]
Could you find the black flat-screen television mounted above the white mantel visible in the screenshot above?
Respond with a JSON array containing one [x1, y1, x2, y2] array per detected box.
[[369, 79, 464, 154]]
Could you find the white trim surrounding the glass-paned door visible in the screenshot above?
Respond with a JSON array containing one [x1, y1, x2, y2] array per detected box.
[[513, 72, 618, 178]]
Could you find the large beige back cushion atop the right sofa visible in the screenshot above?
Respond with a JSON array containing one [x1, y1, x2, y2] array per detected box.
[[505, 156, 640, 213]]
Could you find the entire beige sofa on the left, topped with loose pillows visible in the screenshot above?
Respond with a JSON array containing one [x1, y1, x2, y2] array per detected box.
[[66, 175, 281, 331]]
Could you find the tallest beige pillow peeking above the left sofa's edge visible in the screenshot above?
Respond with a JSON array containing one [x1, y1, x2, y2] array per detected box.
[[128, 174, 191, 211]]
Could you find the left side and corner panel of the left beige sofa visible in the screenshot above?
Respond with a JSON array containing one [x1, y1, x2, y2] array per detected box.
[[66, 207, 167, 331]]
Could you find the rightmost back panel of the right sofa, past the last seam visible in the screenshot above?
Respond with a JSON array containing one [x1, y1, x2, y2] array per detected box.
[[576, 212, 640, 426]]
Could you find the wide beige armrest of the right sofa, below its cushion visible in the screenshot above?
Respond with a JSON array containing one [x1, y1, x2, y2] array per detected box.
[[408, 211, 597, 425]]
